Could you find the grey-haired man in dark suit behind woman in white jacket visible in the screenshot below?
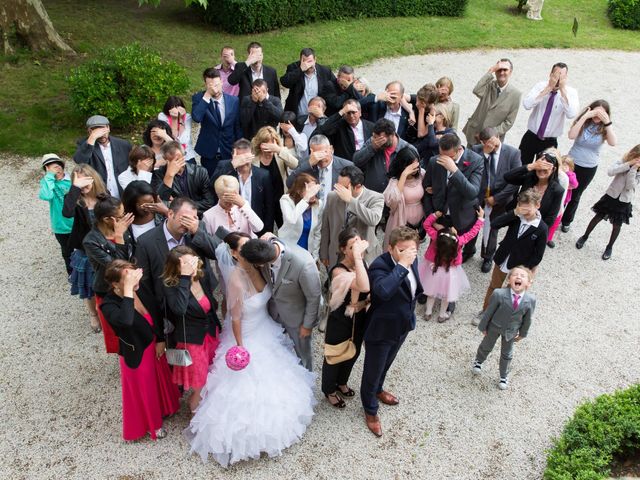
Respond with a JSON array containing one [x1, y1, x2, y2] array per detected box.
[[287, 135, 353, 204]]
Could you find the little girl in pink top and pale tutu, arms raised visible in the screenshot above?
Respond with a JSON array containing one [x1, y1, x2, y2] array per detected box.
[[418, 208, 484, 323]]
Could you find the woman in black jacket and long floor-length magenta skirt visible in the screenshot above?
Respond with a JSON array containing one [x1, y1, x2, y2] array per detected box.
[[100, 260, 180, 441]]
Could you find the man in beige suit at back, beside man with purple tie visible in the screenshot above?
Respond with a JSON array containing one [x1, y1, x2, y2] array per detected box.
[[462, 58, 522, 148]]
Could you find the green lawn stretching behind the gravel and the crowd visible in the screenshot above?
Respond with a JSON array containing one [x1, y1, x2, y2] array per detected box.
[[0, 0, 640, 155]]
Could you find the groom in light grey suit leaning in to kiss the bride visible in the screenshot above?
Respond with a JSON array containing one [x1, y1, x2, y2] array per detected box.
[[240, 233, 321, 371]]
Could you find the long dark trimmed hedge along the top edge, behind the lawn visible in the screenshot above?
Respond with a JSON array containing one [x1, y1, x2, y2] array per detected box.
[[196, 0, 467, 34]]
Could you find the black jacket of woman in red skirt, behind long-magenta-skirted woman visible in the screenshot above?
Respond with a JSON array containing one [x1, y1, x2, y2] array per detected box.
[[82, 226, 133, 297]]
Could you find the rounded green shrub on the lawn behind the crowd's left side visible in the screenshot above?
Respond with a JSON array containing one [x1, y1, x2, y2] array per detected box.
[[68, 44, 189, 128]]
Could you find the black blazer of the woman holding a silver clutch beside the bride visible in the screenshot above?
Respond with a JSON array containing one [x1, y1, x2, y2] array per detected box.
[[164, 270, 220, 345]]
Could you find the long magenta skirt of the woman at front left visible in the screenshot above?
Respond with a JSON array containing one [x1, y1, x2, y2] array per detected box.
[[120, 341, 180, 440]]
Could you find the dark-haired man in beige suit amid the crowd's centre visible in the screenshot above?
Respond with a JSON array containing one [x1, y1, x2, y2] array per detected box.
[[320, 165, 384, 268]]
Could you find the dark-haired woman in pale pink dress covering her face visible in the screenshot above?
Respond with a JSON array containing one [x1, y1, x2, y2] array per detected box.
[[383, 147, 425, 250]]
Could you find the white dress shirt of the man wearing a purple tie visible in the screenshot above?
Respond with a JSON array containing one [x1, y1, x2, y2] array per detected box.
[[522, 81, 580, 138]]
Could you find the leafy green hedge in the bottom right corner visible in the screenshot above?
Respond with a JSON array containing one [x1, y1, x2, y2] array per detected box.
[[544, 385, 640, 480]]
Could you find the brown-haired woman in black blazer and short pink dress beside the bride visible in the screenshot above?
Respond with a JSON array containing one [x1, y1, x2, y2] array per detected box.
[[162, 246, 220, 412]]
